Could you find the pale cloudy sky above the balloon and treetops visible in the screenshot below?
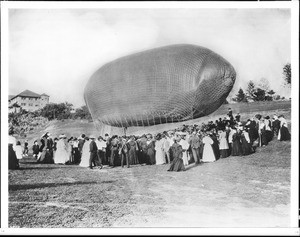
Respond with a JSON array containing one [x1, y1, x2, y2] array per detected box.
[[8, 8, 291, 108]]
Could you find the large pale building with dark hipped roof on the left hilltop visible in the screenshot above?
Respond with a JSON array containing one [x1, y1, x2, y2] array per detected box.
[[8, 90, 49, 112]]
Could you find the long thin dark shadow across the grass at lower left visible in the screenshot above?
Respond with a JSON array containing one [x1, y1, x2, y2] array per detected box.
[[9, 181, 97, 191]]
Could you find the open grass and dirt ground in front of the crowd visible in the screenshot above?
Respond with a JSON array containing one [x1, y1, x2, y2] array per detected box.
[[9, 140, 291, 227]]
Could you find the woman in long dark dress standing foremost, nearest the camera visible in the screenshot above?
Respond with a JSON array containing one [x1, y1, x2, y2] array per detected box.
[[168, 137, 185, 172]]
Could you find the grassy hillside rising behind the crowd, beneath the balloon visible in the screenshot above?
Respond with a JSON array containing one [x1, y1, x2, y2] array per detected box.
[[19, 101, 291, 144]]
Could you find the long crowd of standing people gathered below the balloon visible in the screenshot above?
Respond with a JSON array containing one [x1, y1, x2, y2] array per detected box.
[[9, 109, 291, 171]]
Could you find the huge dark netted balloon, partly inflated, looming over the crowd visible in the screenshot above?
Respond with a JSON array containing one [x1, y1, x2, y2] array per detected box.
[[84, 45, 236, 128]]
